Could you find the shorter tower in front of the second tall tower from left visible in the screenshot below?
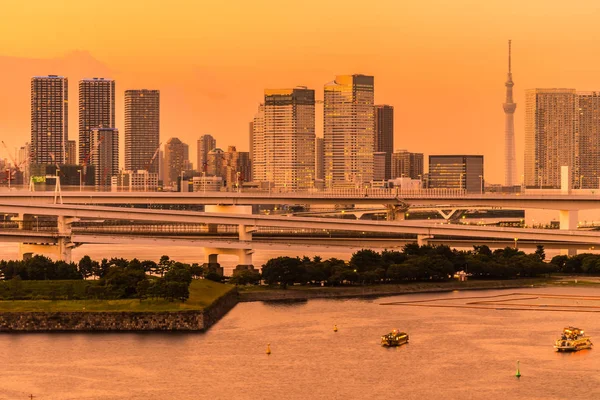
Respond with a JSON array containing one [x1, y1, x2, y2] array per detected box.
[[89, 128, 119, 190]]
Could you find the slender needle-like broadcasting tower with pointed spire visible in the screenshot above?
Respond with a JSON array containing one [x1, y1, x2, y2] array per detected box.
[[502, 40, 518, 186]]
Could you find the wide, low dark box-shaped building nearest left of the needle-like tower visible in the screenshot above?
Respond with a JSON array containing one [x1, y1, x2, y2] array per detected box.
[[428, 155, 485, 193]]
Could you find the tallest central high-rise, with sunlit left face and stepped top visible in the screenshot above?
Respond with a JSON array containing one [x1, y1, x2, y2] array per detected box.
[[323, 75, 375, 188]]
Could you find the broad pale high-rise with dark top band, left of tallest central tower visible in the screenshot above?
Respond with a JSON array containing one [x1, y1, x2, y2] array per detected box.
[[253, 87, 316, 190]]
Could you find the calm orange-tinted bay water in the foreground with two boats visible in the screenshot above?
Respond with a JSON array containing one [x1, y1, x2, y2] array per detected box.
[[0, 288, 600, 400]]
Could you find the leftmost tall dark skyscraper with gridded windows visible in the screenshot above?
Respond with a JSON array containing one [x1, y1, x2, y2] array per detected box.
[[31, 75, 69, 164]]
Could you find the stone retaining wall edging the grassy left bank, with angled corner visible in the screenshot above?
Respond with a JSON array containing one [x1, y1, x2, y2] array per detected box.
[[0, 290, 238, 332]]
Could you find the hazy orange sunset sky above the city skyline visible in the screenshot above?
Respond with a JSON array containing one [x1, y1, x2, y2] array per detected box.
[[0, 0, 600, 183]]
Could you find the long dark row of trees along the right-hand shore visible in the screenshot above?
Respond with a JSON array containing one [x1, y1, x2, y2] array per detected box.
[[230, 244, 558, 288]]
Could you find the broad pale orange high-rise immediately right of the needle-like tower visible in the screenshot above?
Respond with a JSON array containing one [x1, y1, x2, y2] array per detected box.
[[524, 89, 579, 188]]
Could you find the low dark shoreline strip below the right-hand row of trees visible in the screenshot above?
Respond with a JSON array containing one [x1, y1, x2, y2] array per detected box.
[[238, 278, 549, 303]]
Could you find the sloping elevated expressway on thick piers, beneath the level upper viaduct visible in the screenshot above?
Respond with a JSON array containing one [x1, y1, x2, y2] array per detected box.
[[0, 202, 600, 265]]
